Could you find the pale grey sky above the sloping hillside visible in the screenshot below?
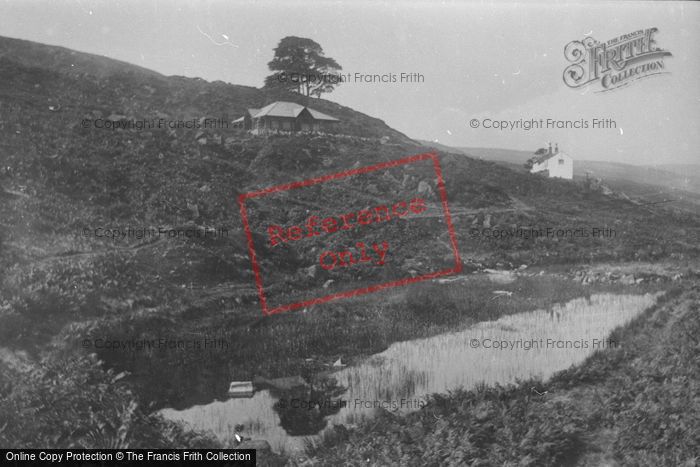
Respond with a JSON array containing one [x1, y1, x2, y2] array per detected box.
[[0, 0, 700, 164]]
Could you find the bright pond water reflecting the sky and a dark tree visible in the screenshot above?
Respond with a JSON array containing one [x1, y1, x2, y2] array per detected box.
[[161, 293, 660, 453]]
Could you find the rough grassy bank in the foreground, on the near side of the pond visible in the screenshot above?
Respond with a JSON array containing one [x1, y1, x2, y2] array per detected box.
[[307, 287, 700, 466]]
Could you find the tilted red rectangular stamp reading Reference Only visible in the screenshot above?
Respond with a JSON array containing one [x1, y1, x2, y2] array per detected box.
[[238, 153, 462, 316]]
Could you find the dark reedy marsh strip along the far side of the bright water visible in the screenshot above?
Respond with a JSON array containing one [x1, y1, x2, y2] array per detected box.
[[75, 275, 668, 408]]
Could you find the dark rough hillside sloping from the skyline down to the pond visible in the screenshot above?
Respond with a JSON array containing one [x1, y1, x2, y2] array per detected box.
[[0, 38, 700, 458]]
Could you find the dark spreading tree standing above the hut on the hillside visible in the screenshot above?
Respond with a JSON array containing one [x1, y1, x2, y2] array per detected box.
[[265, 36, 343, 97]]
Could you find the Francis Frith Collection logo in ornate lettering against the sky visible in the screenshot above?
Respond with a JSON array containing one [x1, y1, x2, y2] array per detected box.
[[564, 28, 671, 92]]
